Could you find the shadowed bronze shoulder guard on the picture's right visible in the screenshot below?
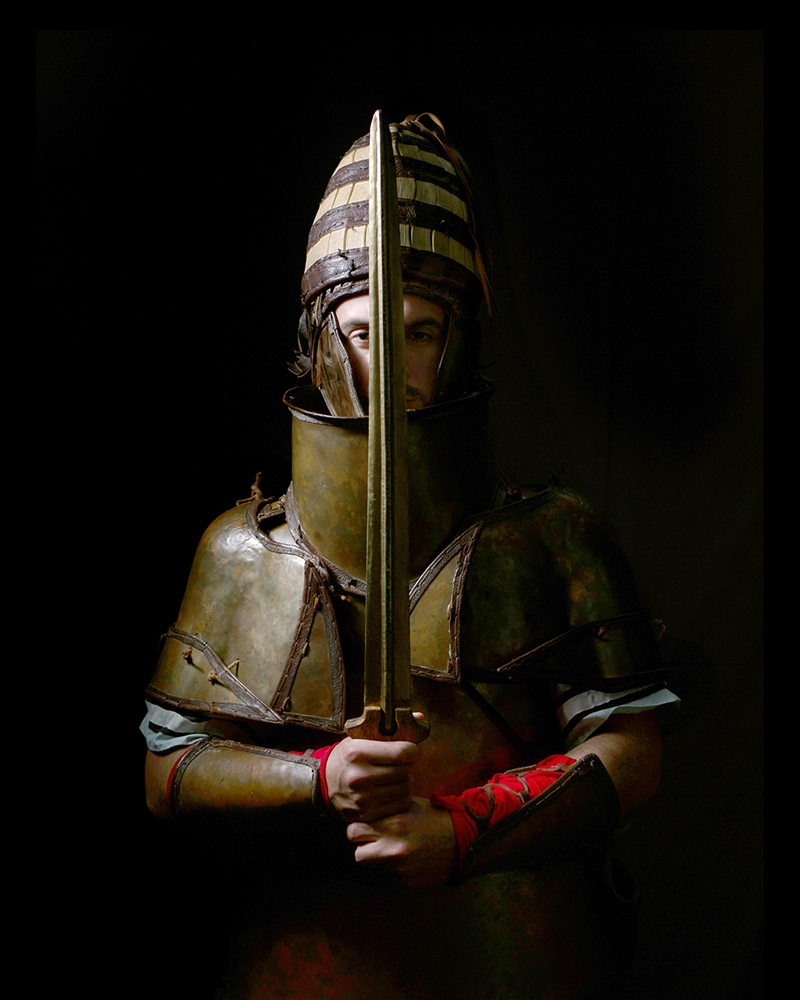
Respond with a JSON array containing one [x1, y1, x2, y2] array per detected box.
[[412, 488, 663, 690]]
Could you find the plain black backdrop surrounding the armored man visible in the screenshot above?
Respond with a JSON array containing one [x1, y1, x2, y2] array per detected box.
[[37, 31, 763, 1000]]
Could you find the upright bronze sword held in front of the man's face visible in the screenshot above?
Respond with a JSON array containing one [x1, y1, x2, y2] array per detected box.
[[345, 111, 430, 743]]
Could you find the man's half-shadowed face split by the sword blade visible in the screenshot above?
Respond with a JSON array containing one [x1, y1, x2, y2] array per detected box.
[[335, 295, 447, 410]]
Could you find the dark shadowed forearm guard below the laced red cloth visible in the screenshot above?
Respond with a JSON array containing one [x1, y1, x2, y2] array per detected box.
[[454, 754, 620, 883]]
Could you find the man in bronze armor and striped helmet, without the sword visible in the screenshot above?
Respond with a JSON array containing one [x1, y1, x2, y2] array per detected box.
[[142, 115, 675, 1000]]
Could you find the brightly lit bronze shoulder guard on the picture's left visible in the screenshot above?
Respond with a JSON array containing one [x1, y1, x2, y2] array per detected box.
[[147, 501, 344, 732]]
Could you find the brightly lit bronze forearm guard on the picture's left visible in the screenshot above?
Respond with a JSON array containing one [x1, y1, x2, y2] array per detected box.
[[169, 737, 328, 825]]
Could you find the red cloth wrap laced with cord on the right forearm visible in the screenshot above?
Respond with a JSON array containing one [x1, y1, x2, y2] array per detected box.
[[430, 754, 575, 869]]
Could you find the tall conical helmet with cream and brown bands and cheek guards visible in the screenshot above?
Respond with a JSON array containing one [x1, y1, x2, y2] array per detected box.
[[290, 114, 491, 416]]
